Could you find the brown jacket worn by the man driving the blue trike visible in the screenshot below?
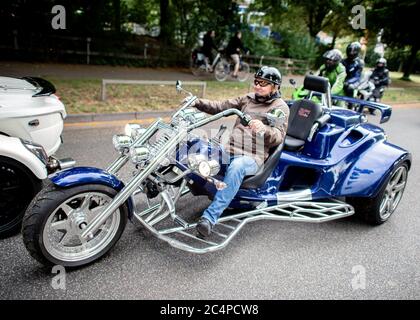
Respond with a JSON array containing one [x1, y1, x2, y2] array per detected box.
[[194, 93, 289, 166]]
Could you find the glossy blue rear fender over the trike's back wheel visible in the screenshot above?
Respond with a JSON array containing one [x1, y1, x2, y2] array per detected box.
[[338, 140, 411, 197]]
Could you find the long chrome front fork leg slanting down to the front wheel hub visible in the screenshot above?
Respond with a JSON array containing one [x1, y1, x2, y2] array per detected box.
[[81, 129, 187, 239]]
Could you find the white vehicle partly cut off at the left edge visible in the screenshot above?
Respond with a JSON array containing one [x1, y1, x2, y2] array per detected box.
[[0, 77, 75, 238]]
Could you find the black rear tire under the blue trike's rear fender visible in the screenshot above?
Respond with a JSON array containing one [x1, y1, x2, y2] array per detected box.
[[347, 162, 408, 225]]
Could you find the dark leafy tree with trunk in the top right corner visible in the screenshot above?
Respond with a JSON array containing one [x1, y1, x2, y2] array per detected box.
[[367, 0, 420, 80]]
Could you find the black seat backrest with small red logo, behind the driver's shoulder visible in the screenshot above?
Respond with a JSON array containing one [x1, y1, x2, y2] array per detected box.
[[287, 99, 322, 140]]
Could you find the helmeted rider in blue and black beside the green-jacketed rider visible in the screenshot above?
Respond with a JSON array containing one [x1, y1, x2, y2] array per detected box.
[[342, 42, 365, 97]]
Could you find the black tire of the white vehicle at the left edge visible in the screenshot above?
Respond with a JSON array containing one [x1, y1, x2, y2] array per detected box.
[[0, 156, 42, 239]]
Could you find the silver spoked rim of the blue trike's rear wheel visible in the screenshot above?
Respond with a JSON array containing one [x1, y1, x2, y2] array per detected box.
[[379, 166, 407, 221]]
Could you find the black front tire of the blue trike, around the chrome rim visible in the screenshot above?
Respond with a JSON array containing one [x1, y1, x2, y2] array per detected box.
[[22, 183, 128, 267]]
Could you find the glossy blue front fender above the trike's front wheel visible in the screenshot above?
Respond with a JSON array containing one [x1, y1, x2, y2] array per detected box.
[[50, 167, 134, 220]]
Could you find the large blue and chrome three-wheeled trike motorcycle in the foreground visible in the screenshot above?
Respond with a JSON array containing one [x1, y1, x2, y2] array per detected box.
[[22, 76, 411, 267]]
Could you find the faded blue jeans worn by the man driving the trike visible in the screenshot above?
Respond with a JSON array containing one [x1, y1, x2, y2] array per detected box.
[[203, 156, 258, 225]]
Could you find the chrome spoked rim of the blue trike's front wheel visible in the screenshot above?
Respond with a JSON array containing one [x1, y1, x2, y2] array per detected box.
[[43, 192, 120, 262]]
